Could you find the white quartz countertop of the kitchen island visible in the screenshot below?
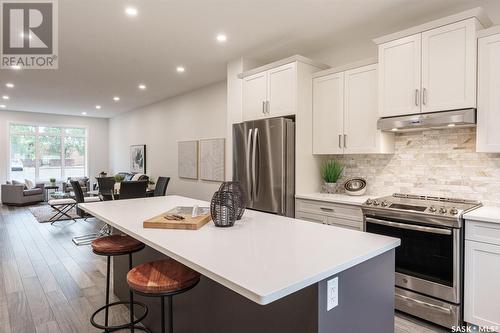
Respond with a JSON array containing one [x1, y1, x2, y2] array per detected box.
[[79, 196, 400, 305]]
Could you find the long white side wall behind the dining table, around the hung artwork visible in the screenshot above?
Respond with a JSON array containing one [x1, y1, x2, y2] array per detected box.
[[109, 82, 227, 200]]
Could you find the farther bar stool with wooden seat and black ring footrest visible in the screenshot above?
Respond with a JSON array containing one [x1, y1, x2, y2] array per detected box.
[[90, 235, 150, 332]]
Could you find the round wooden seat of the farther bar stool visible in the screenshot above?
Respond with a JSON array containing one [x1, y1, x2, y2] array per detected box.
[[92, 235, 145, 256]]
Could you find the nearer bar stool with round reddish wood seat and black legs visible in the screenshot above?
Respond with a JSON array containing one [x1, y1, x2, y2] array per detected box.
[[127, 259, 200, 333]]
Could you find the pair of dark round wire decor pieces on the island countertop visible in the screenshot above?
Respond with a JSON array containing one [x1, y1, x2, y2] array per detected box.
[[210, 182, 245, 227]]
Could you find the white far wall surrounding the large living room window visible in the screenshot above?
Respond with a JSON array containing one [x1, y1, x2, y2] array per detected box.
[[0, 110, 109, 188]]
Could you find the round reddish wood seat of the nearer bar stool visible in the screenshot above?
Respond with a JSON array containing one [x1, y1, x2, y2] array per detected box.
[[127, 259, 200, 295]]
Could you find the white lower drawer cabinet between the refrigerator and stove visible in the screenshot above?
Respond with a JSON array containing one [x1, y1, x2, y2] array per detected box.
[[295, 199, 363, 230]]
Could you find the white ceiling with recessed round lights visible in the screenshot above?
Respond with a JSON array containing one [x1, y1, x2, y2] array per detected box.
[[0, 0, 500, 117]]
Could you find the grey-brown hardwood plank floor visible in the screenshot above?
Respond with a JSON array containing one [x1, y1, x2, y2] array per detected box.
[[0, 205, 447, 333]]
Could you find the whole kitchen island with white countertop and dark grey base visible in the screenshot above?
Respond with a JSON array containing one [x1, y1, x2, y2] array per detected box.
[[79, 196, 400, 333]]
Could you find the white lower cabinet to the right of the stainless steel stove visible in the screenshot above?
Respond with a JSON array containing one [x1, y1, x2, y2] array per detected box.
[[464, 221, 500, 330]]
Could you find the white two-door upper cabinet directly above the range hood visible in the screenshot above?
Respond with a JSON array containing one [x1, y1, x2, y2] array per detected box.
[[379, 18, 480, 117]]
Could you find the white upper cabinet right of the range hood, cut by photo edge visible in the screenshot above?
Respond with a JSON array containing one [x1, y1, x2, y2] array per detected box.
[[476, 29, 500, 153]]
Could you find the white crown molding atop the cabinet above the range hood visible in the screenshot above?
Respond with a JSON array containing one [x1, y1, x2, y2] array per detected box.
[[373, 7, 493, 45]]
